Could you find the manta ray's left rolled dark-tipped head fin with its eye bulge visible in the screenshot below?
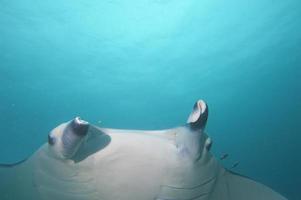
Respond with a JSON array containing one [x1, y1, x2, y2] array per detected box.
[[48, 117, 90, 159]]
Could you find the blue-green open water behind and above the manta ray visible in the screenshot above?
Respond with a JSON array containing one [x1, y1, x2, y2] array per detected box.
[[0, 0, 301, 200]]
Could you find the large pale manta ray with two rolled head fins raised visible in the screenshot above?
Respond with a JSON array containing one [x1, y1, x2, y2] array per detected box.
[[0, 100, 286, 200]]
